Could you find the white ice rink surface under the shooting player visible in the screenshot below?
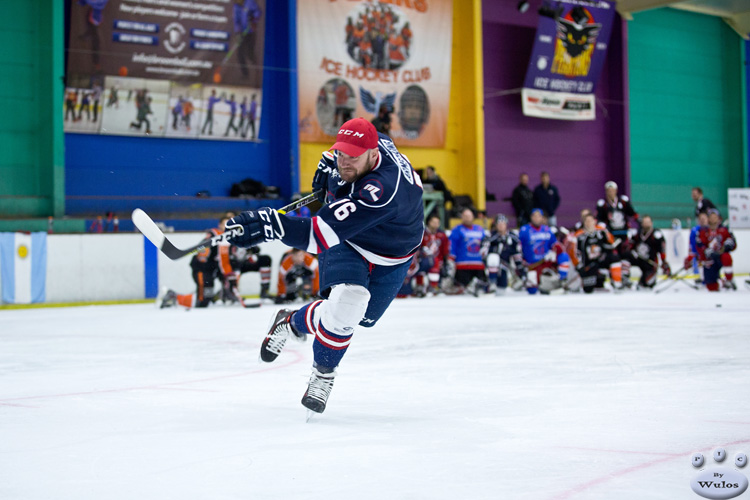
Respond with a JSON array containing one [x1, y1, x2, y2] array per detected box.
[[0, 290, 750, 500]]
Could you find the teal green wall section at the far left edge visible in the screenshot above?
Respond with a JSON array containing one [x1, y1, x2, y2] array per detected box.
[[0, 0, 65, 218]]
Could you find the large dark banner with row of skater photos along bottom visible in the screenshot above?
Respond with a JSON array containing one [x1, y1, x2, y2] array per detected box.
[[63, 0, 266, 140]]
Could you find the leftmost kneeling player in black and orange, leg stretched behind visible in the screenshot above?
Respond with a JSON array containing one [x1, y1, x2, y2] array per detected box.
[[162, 217, 232, 309]]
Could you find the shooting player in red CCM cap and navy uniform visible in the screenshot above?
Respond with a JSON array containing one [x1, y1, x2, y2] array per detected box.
[[227, 118, 424, 413]]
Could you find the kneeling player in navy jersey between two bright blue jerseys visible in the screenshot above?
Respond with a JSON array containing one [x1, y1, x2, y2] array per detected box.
[[487, 214, 526, 295]]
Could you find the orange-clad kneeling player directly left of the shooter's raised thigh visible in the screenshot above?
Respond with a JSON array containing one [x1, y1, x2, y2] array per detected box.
[[276, 248, 320, 304]]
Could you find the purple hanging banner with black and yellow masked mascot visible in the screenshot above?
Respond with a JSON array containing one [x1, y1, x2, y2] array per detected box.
[[521, 0, 615, 120]]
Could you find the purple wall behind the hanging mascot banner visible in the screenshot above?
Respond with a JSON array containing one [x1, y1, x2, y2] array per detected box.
[[482, 0, 629, 226]]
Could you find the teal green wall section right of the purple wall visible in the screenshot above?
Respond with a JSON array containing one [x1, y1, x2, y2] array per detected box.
[[628, 8, 745, 227]]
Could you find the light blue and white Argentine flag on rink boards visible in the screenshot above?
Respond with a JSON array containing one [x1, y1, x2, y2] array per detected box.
[[0, 233, 47, 304]]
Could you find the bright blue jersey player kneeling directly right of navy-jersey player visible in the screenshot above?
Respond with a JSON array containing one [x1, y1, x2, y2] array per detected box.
[[518, 208, 570, 294]]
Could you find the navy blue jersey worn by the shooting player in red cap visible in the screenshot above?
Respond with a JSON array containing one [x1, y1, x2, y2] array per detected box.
[[280, 134, 424, 266]]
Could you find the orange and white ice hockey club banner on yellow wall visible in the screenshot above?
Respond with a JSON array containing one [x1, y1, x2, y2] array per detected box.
[[297, 0, 453, 147]]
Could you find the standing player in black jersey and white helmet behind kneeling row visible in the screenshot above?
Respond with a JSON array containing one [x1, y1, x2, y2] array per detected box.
[[596, 181, 638, 287]]
